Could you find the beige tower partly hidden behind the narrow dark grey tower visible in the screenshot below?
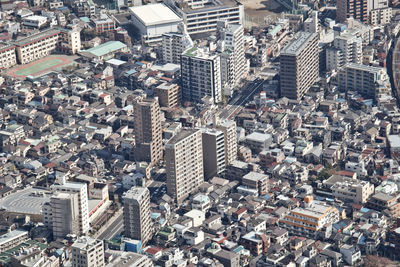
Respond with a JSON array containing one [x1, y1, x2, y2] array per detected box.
[[216, 120, 237, 166]]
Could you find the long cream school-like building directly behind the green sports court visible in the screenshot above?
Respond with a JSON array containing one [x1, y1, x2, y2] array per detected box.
[[14, 29, 60, 64]]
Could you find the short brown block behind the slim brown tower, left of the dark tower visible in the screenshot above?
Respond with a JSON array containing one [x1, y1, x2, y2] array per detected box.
[[154, 83, 182, 108]]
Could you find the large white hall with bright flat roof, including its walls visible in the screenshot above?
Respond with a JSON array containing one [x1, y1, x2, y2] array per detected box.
[[129, 3, 182, 45]]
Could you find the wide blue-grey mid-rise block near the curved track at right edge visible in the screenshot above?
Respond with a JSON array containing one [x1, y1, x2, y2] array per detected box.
[[337, 63, 391, 99]]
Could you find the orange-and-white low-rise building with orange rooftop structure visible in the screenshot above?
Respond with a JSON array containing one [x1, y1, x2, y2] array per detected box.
[[279, 196, 339, 237]]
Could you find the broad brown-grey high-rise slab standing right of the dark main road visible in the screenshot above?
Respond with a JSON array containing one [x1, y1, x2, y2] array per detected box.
[[280, 32, 319, 100]]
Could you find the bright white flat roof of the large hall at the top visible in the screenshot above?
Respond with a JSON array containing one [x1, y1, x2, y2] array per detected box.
[[129, 3, 182, 26]]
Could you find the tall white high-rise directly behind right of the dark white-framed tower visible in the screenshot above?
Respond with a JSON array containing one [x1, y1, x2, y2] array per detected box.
[[217, 20, 248, 91]]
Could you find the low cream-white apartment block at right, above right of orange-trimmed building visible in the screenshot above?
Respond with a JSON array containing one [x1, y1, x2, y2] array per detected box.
[[331, 179, 375, 204]]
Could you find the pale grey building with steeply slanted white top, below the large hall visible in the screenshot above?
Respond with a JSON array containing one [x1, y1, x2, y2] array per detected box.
[[162, 24, 193, 64]]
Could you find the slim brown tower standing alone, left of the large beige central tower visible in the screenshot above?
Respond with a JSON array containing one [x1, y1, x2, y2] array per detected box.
[[134, 98, 163, 165]]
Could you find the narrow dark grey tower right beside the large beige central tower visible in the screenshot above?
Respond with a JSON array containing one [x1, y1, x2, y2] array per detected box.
[[202, 129, 225, 180]]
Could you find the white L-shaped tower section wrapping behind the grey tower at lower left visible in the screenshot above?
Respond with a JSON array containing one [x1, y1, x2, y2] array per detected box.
[[51, 182, 90, 237]]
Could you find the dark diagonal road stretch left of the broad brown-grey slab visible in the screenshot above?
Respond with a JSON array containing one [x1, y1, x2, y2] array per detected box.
[[219, 78, 264, 120]]
